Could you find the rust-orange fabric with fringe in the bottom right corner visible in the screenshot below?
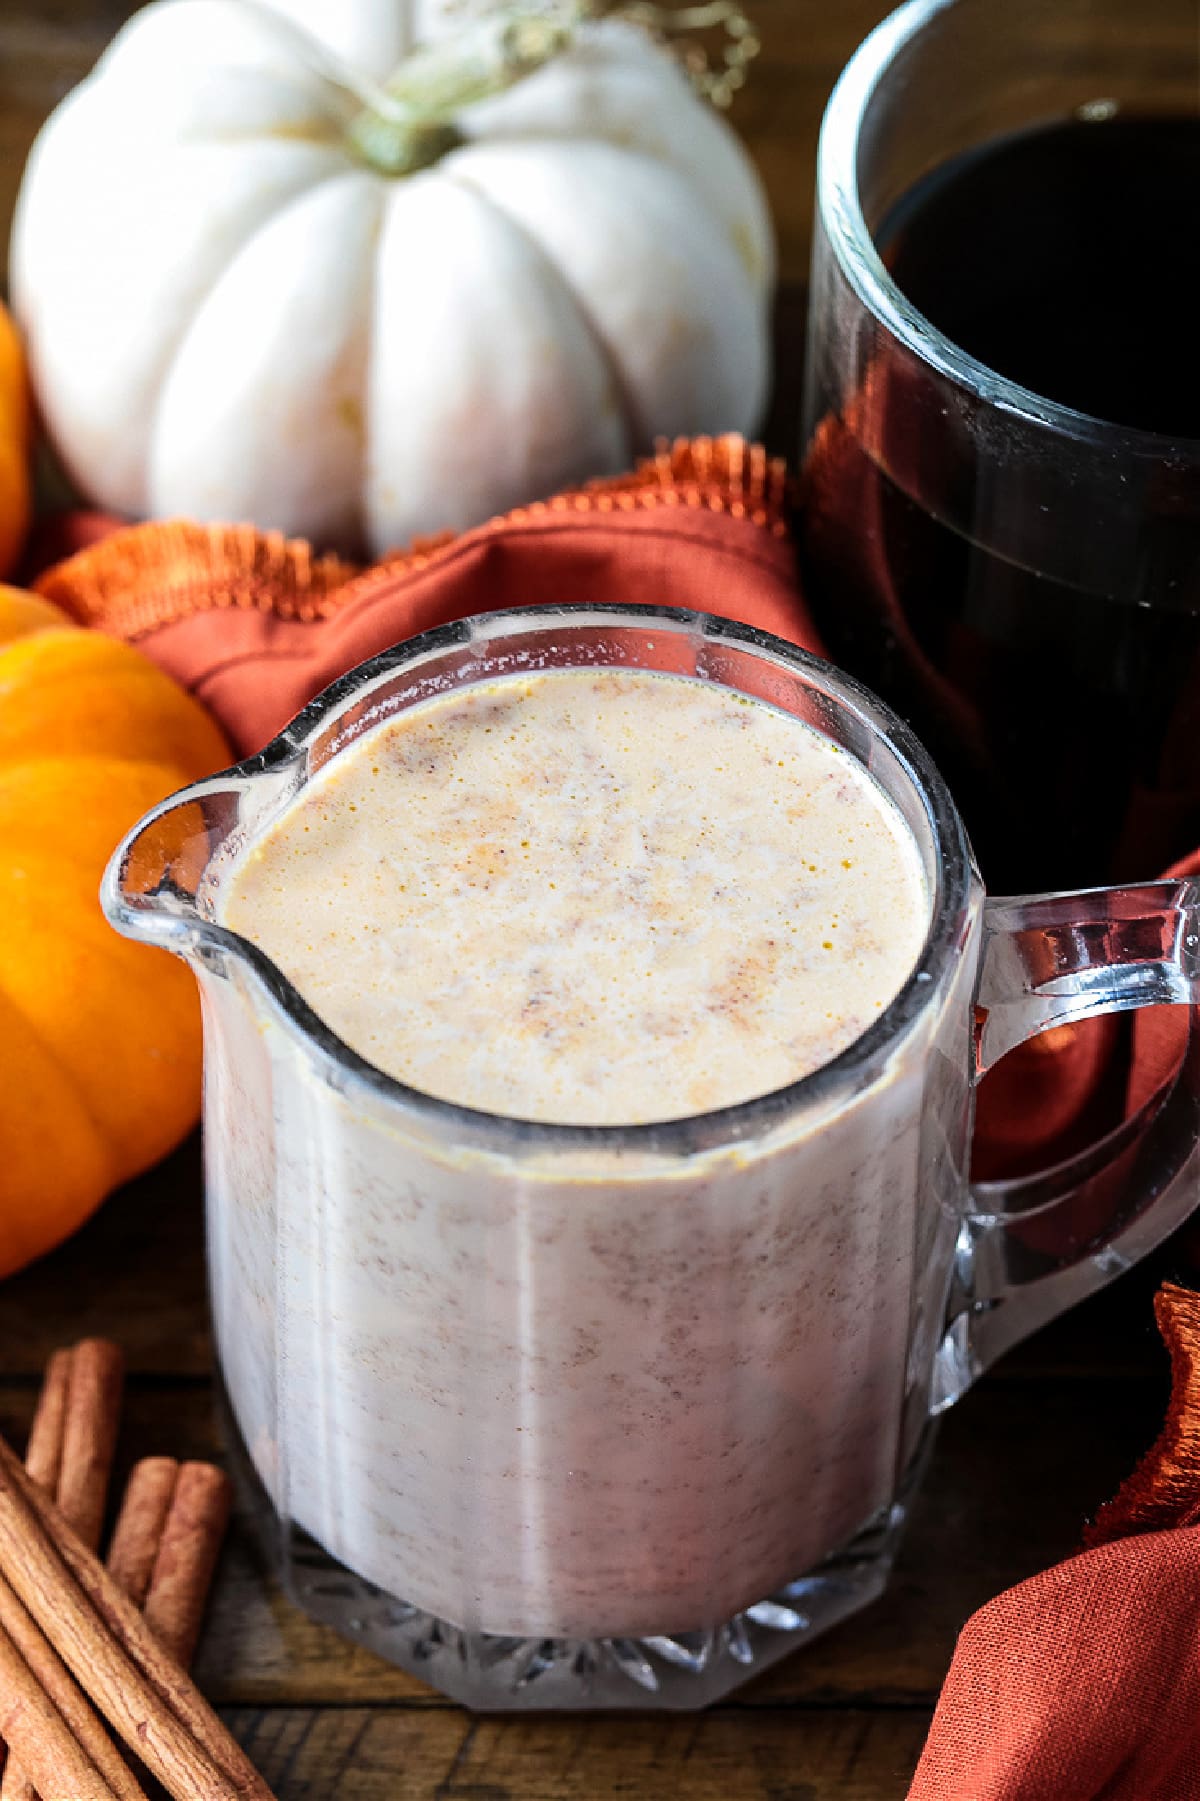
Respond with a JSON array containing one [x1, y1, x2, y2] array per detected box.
[[908, 1286, 1200, 1801]]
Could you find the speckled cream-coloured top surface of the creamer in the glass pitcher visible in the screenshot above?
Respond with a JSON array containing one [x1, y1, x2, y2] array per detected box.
[[220, 668, 930, 1126]]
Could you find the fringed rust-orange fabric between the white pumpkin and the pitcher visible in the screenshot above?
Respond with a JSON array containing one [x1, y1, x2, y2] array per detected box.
[[36, 438, 807, 753]]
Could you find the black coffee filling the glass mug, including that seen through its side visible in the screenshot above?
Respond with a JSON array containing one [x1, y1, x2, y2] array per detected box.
[[802, 56, 1200, 890]]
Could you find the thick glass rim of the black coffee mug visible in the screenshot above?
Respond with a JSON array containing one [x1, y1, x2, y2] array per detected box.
[[816, 0, 1200, 461]]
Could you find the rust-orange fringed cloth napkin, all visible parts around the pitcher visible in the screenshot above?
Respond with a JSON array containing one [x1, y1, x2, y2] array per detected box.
[[25, 438, 1200, 1801]]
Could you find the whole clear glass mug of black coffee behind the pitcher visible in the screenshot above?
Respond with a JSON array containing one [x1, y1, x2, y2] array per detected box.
[[798, 0, 1200, 888]]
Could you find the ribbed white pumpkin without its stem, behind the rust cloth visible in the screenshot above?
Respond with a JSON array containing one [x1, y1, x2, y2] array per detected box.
[[11, 0, 771, 553]]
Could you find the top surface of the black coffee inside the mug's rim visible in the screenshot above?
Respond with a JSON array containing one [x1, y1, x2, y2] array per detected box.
[[874, 115, 1200, 438]]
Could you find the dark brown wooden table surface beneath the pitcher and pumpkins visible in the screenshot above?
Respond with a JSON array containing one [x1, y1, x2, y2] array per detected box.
[[0, 0, 1171, 1801]]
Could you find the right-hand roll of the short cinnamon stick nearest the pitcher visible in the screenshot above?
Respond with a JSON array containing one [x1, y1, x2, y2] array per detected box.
[[144, 1462, 232, 1668]]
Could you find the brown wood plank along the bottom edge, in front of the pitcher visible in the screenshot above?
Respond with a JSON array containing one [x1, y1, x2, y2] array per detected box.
[[229, 1707, 928, 1801]]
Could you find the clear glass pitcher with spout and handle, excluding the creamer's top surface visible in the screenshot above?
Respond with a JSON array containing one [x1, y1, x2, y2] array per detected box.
[[103, 607, 1200, 1709]]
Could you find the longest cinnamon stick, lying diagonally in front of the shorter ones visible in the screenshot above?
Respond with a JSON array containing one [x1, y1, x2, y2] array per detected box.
[[0, 1437, 274, 1801]]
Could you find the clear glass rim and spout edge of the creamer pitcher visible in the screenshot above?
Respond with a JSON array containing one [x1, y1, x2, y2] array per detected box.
[[101, 603, 980, 1156]]
